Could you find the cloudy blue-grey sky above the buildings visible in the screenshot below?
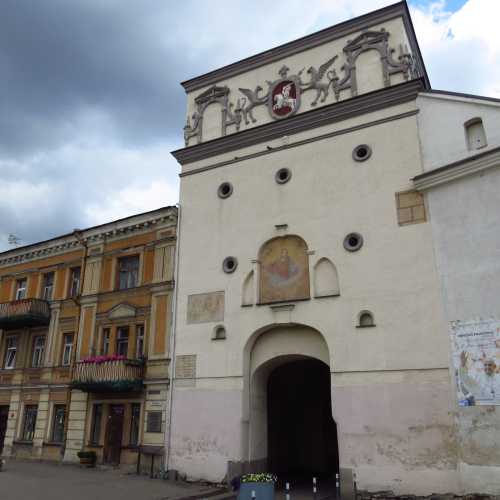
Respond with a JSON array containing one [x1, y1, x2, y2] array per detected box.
[[0, 0, 500, 251]]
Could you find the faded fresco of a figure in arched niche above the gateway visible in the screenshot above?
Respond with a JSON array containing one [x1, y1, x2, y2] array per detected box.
[[259, 235, 310, 304]]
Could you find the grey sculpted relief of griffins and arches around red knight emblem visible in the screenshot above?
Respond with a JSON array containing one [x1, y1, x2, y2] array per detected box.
[[184, 28, 420, 146]]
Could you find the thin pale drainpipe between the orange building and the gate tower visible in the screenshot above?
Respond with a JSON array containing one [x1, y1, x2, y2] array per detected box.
[[165, 203, 182, 471]]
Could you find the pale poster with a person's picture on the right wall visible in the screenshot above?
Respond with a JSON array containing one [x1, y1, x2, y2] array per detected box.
[[451, 319, 500, 406]]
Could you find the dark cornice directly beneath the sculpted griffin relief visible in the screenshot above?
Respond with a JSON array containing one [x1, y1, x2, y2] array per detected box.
[[172, 78, 425, 165]]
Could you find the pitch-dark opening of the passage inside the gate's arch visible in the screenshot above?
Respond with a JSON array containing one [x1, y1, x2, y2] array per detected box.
[[267, 359, 338, 477]]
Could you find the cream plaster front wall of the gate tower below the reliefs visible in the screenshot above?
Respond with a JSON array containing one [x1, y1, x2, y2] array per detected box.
[[171, 96, 456, 493]]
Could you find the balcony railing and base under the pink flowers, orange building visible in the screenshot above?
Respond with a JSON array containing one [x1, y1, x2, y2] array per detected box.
[[71, 356, 144, 392]]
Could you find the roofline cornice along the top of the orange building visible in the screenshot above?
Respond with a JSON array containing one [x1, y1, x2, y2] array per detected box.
[[0, 207, 177, 267]]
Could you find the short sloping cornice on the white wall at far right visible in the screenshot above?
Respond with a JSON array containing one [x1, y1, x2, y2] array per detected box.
[[412, 147, 500, 191]]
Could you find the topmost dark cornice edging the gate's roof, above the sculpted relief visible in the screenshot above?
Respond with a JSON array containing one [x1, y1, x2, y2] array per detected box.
[[181, 1, 430, 92]]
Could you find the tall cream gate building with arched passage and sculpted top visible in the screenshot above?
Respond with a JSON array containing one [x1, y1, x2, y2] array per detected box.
[[168, 2, 500, 493]]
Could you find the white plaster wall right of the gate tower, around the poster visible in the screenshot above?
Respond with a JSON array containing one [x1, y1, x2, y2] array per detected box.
[[417, 93, 500, 494]]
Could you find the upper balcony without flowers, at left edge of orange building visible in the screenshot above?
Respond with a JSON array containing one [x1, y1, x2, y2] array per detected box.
[[0, 299, 50, 330]]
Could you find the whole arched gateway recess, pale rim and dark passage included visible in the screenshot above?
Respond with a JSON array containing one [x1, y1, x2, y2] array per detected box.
[[249, 325, 338, 479]]
